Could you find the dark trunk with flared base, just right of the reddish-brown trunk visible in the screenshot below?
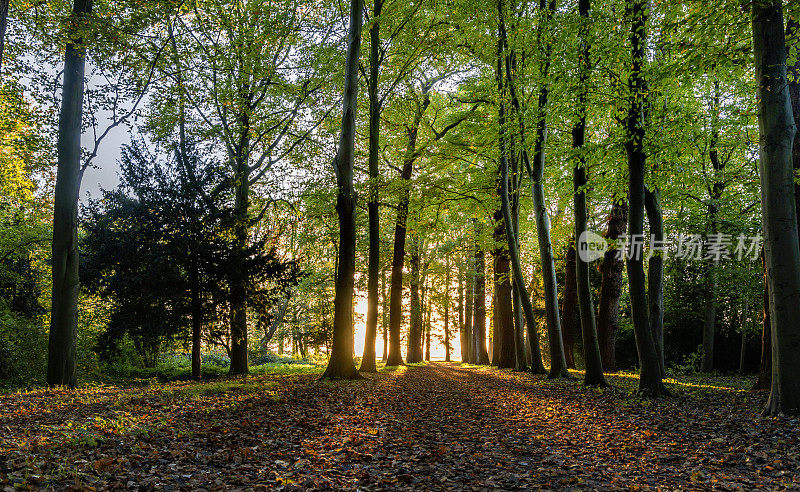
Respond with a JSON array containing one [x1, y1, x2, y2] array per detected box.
[[625, 0, 667, 396]]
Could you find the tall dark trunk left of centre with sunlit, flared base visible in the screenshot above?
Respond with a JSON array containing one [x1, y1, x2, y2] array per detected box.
[[322, 0, 364, 379]]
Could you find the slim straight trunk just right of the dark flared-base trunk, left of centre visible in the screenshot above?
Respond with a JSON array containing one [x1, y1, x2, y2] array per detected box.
[[359, 0, 383, 372]]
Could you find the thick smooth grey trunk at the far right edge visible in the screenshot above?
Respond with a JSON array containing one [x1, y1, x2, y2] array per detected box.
[[751, 0, 800, 415]]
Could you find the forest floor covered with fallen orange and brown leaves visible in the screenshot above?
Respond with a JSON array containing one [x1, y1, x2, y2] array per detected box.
[[0, 363, 800, 490]]
